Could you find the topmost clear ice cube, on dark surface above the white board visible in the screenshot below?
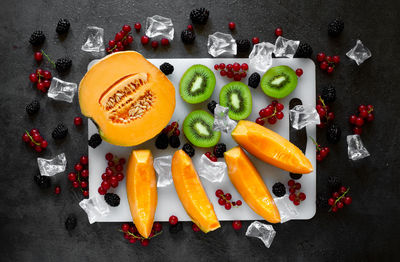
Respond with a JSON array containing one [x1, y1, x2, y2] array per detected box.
[[145, 15, 174, 40]]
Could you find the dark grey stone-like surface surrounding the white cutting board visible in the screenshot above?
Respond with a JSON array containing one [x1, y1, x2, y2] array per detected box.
[[0, 0, 400, 261]]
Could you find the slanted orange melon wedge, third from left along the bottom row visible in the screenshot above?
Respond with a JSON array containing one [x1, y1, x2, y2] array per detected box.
[[224, 147, 281, 223]]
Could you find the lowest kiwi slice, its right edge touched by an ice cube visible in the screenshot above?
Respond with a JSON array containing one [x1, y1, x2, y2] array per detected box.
[[183, 110, 221, 147]]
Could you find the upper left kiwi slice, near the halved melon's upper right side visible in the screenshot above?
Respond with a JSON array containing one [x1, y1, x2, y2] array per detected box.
[[179, 65, 215, 104]]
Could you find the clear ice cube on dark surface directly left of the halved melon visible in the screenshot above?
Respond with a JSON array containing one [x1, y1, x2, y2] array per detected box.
[[47, 77, 78, 103]]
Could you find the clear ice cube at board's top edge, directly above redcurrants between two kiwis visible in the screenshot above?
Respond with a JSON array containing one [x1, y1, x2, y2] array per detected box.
[[207, 32, 237, 57]]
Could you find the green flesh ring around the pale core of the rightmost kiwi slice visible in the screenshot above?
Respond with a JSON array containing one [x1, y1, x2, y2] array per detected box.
[[260, 65, 297, 99]]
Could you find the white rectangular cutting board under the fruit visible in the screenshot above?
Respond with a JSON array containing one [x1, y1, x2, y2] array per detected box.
[[88, 58, 316, 222]]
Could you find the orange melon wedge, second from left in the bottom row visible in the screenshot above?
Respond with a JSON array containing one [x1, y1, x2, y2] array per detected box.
[[171, 150, 220, 233]]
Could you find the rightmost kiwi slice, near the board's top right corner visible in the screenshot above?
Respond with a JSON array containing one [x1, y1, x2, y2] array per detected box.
[[260, 66, 297, 98]]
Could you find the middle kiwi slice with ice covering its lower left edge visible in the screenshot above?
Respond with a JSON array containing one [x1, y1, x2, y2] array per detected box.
[[219, 81, 253, 120]]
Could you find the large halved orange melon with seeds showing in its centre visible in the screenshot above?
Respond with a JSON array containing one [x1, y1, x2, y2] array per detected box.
[[79, 51, 175, 146]]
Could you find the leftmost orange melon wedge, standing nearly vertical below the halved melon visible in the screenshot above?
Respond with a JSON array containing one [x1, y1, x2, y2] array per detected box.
[[126, 150, 157, 238]]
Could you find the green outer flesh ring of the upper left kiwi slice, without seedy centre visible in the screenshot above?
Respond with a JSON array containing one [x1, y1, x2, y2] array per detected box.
[[179, 65, 216, 104]]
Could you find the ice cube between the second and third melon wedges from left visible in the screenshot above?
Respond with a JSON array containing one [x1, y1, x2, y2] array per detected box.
[[196, 154, 227, 183]]
